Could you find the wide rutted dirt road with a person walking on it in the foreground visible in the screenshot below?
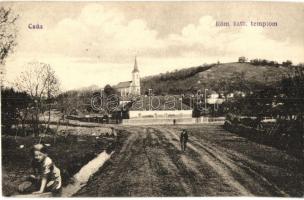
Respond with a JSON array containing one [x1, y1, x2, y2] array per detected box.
[[76, 125, 304, 197]]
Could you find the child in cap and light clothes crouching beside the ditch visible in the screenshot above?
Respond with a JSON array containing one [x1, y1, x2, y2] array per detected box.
[[19, 144, 61, 194]]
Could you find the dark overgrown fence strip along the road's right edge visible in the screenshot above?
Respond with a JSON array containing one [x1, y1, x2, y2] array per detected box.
[[224, 115, 304, 159]]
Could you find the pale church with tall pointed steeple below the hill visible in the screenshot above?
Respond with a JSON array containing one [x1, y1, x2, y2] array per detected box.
[[114, 57, 140, 96]]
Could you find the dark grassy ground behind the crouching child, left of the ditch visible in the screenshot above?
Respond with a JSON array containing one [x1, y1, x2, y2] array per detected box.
[[2, 127, 124, 196]]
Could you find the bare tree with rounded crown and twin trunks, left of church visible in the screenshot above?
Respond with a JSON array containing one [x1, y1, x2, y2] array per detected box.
[[15, 62, 59, 136]]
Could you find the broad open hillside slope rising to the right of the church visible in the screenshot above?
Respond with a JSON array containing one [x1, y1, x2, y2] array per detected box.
[[141, 63, 287, 95]]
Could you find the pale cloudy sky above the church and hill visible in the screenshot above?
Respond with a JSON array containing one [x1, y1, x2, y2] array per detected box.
[[1, 2, 304, 91]]
